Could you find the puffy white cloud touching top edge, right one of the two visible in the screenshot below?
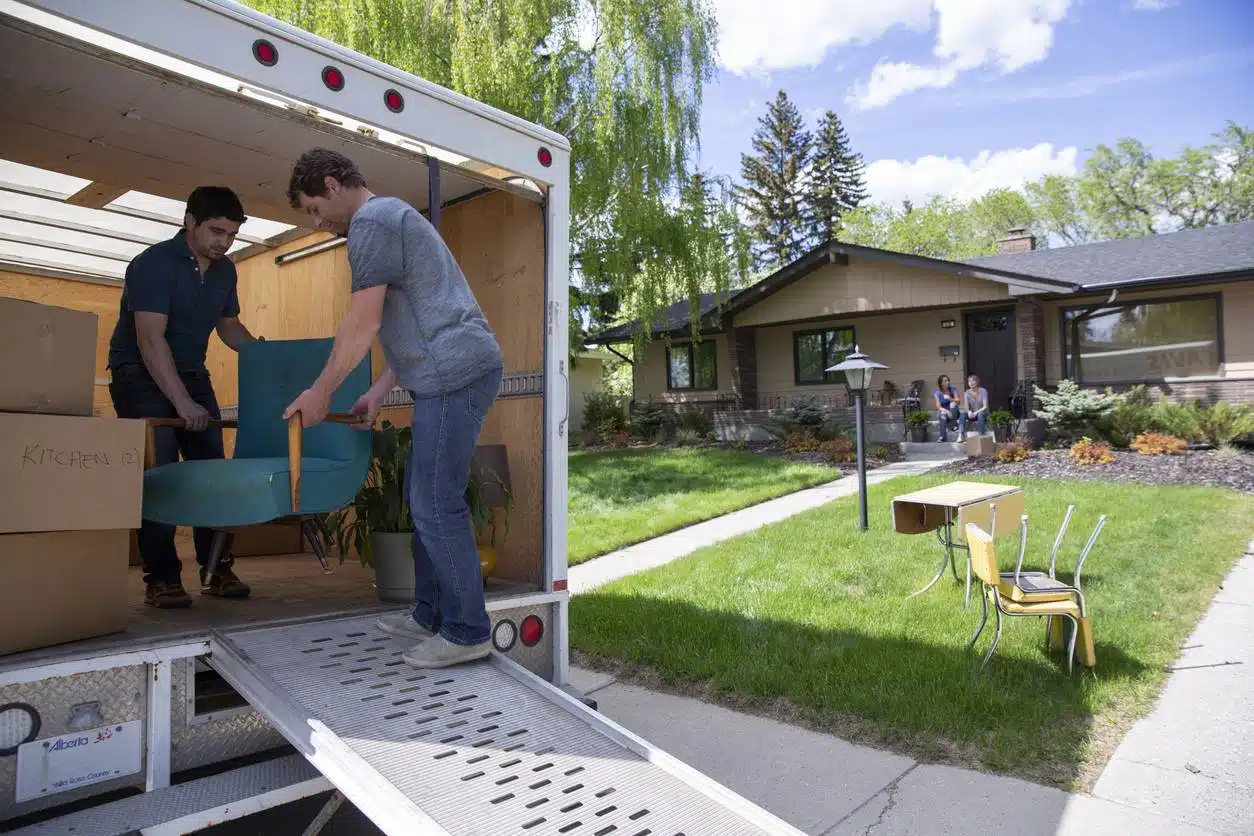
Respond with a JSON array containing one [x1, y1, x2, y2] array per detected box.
[[849, 0, 1071, 109]]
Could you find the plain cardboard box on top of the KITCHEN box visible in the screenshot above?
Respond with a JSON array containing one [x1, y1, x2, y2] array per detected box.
[[0, 296, 99, 415]]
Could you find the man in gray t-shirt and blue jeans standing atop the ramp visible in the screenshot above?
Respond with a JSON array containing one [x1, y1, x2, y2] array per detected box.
[[283, 148, 504, 668]]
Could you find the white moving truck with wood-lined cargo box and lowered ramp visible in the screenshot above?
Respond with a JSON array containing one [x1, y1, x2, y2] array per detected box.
[[0, 0, 799, 836]]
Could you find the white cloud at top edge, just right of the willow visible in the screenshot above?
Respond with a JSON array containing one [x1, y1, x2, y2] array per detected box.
[[714, 0, 933, 75]]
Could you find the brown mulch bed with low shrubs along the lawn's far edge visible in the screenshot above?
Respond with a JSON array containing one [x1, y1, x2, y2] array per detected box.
[[938, 450, 1254, 493]]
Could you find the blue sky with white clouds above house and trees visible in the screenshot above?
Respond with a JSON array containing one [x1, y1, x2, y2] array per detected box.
[[700, 0, 1254, 204]]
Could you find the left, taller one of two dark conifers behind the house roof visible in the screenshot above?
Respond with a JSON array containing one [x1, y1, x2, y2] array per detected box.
[[737, 90, 813, 268]]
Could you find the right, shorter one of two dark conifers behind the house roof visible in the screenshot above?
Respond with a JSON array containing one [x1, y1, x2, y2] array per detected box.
[[806, 110, 867, 246]]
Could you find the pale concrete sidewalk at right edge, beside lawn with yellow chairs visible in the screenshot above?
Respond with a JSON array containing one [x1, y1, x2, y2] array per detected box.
[[1093, 541, 1254, 833]]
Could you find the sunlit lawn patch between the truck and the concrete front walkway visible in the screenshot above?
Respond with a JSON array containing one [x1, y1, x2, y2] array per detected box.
[[567, 447, 840, 565]]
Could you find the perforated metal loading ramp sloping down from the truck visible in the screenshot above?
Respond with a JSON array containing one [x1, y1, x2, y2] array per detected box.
[[209, 615, 801, 836]]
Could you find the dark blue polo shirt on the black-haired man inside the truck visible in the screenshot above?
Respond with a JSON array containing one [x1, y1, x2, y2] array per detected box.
[[109, 231, 240, 371]]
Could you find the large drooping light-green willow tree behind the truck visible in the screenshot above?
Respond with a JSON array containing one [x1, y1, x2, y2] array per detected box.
[[248, 0, 746, 348]]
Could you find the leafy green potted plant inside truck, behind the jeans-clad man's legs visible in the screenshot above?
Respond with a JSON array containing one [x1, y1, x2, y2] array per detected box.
[[327, 421, 512, 603]]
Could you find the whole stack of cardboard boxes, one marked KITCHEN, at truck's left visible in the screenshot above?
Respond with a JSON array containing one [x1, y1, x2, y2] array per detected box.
[[0, 297, 144, 653]]
